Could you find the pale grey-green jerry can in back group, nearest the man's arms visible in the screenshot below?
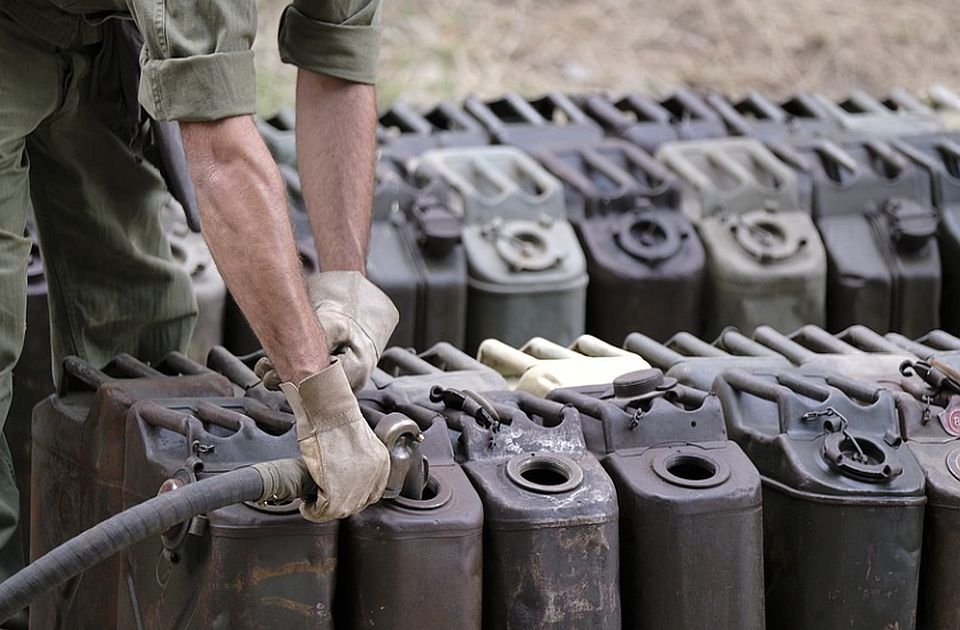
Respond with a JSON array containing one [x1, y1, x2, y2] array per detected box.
[[418, 147, 587, 351]]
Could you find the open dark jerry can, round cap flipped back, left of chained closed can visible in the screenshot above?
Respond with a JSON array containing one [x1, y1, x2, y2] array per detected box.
[[549, 369, 764, 630]]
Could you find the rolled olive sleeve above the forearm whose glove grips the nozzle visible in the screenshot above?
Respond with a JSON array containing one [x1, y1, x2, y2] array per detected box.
[[129, 0, 257, 121]]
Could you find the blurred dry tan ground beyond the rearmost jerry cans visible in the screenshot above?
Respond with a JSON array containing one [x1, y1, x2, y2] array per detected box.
[[257, 0, 960, 113]]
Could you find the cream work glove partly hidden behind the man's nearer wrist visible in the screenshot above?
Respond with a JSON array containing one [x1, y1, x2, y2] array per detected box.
[[254, 271, 400, 392]]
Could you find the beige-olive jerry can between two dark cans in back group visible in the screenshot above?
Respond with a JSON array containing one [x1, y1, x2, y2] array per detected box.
[[657, 138, 827, 336]]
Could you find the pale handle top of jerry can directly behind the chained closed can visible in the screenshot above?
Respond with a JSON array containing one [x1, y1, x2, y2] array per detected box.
[[753, 325, 912, 381]]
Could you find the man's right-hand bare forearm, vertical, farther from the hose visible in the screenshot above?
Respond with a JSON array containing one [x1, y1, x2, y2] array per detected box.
[[297, 70, 377, 272]]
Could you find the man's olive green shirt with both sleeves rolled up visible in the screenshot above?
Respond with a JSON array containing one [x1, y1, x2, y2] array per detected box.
[[0, 0, 381, 120]]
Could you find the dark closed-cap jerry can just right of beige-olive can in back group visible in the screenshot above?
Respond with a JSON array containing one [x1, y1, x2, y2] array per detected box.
[[792, 139, 941, 336]]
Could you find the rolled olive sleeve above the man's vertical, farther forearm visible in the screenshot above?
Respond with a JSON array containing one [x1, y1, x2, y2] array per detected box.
[[279, 0, 382, 84]]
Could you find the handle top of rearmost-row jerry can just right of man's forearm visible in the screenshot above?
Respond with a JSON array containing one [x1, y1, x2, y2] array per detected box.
[[377, 101, 489, 157]]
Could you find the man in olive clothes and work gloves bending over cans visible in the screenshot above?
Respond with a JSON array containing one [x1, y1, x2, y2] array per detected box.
[[0, 0, 397, 578]]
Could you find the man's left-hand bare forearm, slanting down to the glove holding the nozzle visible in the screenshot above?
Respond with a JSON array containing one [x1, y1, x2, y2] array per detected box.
[[181, 116, 330, 383]]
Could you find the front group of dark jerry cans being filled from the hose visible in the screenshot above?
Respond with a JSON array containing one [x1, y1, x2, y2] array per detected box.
[[22, 325, 960, 630]]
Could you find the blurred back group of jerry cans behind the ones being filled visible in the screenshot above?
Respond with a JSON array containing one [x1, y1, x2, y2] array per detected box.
[[244, 90, 960, 360]]
